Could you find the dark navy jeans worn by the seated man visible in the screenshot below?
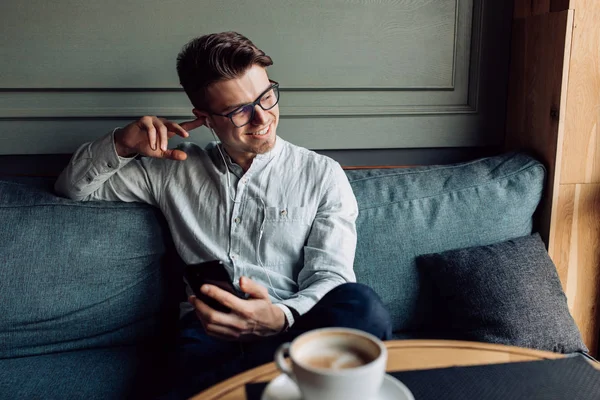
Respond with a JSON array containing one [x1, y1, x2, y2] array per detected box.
[[155, 283, 392, 399]]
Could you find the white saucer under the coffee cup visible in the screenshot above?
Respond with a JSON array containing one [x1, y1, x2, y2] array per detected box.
[[261, 374, 415, 400]]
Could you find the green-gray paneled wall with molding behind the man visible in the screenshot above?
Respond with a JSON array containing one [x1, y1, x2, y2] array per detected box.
[[0, 0, 512, 164]]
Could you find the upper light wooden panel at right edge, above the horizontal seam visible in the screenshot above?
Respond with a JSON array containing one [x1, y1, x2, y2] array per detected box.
[[561, 0, 600, 183]]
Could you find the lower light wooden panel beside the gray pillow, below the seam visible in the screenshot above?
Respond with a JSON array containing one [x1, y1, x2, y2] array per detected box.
[[552, 184, 600, 354]]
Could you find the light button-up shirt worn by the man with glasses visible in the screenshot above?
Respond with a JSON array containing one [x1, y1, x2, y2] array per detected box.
[[56, 132, 358, 324]]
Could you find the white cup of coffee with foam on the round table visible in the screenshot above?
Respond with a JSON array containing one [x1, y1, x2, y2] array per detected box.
[[275, 328, 387, 400]]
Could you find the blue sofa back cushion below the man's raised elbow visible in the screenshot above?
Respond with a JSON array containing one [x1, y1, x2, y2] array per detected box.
[[0, 180, 181, 359]]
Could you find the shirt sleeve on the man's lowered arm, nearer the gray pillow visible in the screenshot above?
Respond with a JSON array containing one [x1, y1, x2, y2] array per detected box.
[[281, 163, 358, 315]]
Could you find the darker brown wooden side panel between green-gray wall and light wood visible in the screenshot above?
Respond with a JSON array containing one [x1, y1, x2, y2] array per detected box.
[[505, 11, 573, 248]]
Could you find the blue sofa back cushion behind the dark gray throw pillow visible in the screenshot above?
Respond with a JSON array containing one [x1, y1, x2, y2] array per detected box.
[[346, 153, 545, 331]]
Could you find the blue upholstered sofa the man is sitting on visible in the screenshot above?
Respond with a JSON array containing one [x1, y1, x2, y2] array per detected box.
[[0, 153, 587, 399]]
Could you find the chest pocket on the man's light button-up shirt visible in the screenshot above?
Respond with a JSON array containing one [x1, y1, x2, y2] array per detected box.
[[258, 207, 313, 268]]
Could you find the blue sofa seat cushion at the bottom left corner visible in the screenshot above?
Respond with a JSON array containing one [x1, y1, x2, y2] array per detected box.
[[0, 346, 160, 400]]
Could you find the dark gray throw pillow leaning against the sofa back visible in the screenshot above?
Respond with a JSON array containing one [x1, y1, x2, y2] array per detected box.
[[417, 234, 588, 353]]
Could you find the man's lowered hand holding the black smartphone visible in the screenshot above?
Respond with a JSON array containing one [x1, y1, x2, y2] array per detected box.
[[188, 277, 285, 340]]
